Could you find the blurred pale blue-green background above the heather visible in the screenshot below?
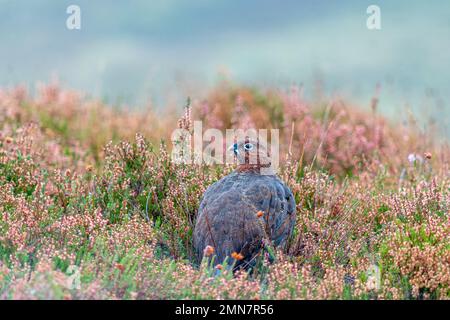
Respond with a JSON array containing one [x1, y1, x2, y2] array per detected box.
[[0, 0, 450, 137]]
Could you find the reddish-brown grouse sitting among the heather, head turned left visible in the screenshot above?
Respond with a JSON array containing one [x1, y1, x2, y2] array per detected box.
[[193, 137, 296, 270]]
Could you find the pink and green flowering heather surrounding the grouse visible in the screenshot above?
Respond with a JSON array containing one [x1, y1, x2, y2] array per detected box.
[[0, 83, 450, 299]]
